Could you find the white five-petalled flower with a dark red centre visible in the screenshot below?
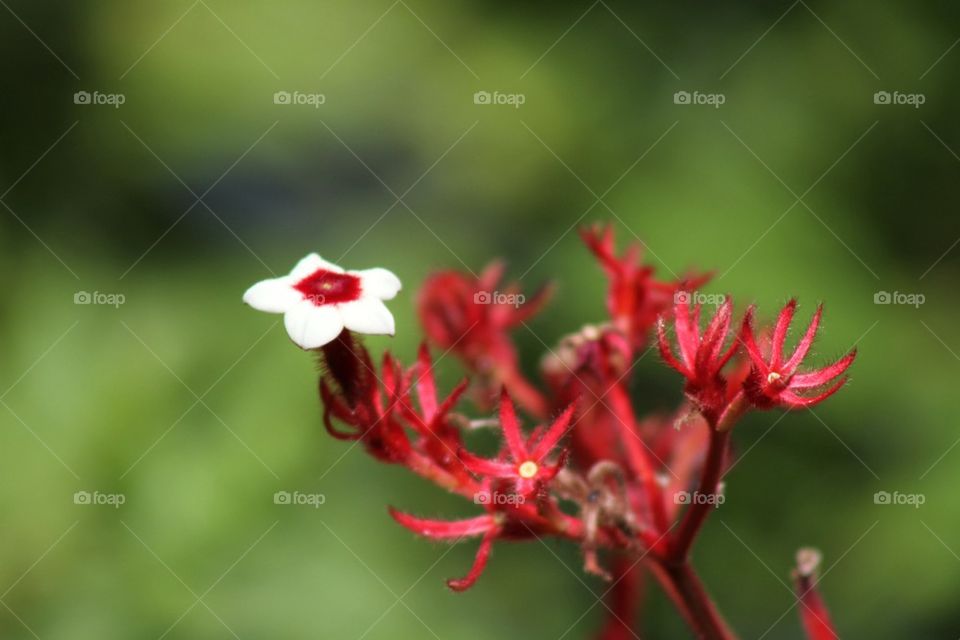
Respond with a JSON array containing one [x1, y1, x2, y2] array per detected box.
[[243, 253, 400, 349]]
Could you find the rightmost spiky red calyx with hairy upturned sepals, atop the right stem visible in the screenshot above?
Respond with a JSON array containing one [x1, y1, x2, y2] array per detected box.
[[740, 300, 857, 409]]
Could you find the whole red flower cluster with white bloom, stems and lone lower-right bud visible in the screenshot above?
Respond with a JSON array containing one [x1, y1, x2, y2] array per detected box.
[[244, 234, 856, 640]]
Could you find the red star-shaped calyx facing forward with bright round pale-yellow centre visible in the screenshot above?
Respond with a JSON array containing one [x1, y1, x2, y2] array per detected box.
[[460, 389, 576, 498]]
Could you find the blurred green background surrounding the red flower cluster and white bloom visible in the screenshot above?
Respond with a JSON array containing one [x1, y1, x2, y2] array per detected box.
[[0, 0, 960, 640]]
